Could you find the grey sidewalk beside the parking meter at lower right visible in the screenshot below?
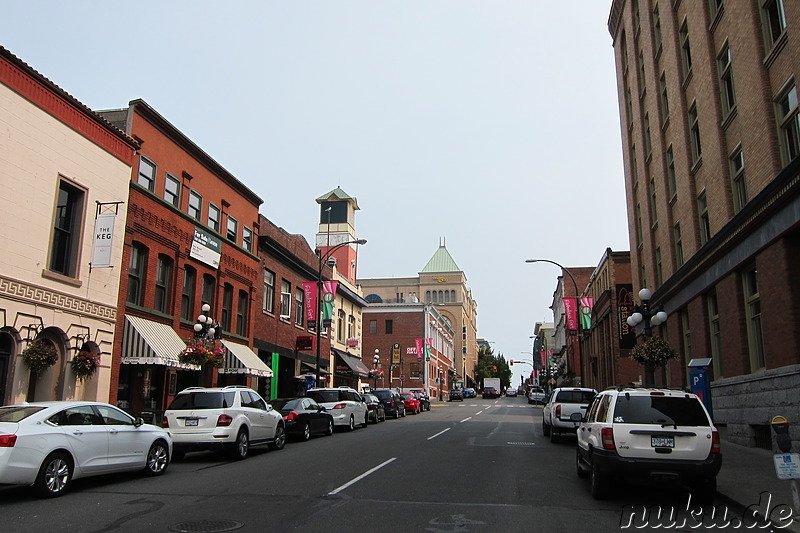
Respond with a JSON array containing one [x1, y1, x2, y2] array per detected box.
[[717, 440, 800, 533]]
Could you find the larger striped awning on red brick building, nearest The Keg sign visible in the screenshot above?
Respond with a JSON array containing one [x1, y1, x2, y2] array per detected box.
[[120, 316, 200, 370]]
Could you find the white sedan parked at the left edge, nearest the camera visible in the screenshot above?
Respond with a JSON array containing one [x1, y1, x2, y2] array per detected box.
[[0, 401, 172, 498]]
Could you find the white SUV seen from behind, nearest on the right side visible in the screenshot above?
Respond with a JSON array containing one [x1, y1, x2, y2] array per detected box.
[[575, 387, 722, 503]]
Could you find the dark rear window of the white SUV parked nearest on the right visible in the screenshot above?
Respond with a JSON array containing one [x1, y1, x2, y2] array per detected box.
[[614, 396, 709, 426]]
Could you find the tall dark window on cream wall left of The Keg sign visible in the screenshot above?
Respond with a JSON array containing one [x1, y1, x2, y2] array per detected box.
[[50, 180, 85, 278]]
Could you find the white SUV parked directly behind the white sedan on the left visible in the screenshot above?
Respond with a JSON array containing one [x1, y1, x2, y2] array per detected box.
[[162, 385, 286, 459]]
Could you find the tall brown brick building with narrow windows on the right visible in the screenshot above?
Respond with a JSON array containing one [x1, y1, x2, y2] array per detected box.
[[608, 0, 800, 448]]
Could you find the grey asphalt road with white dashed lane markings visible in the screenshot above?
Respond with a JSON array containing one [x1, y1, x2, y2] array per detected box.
[[0, 398, 756, 533]]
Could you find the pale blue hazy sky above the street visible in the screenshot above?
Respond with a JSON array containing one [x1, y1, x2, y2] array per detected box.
[[0, 0, 630, 384]]
